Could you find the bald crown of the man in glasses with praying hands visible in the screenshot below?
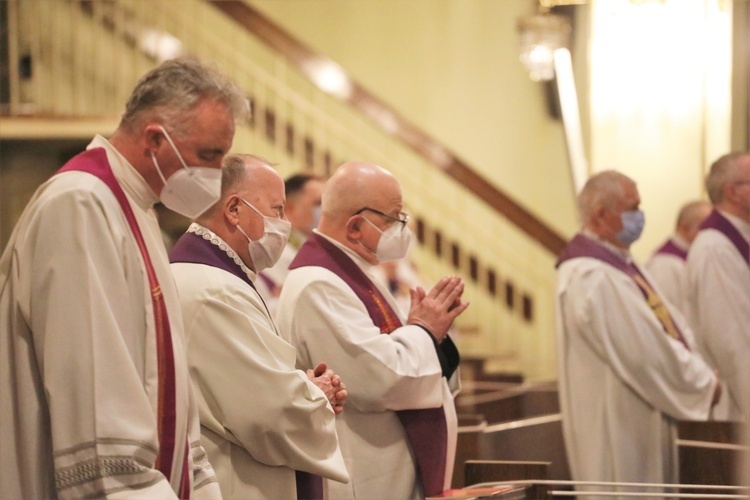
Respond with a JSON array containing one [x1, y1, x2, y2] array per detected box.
[[321, 161, 402, 225]]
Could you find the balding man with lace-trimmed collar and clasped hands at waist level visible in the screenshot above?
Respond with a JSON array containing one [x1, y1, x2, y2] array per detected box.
[[170, 155, 349, 499]]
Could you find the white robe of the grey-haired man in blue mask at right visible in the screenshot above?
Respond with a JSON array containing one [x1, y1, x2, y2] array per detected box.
[[557, 250, 716, 496]]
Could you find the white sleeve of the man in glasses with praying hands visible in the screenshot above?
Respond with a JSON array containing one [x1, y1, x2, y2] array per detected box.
[[279, 268, 443, 411]]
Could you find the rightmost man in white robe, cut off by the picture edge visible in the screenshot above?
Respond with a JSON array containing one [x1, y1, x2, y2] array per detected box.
[[687, 153, 750, 420]]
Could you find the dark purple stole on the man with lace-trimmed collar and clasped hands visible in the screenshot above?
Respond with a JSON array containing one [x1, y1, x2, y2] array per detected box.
[[169, 233, 323, 500]]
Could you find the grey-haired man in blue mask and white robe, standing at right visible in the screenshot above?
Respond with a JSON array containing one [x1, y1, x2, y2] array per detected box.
[[557, 171, 721, 496]]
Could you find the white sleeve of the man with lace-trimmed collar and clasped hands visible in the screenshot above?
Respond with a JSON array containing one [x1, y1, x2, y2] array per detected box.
[[172, 264, 348, 481]]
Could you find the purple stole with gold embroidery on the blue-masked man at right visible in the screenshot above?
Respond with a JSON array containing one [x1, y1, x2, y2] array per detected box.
[[555, 234, 690, 350]]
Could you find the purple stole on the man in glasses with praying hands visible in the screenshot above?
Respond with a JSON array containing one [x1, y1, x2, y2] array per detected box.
[[289, 233, 450, 496]]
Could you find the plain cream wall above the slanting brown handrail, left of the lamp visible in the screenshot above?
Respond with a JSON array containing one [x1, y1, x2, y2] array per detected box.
[[249, 0, 576, 236]]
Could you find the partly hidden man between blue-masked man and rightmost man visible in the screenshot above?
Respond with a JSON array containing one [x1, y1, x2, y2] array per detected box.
[[646, 200, 711, 315]]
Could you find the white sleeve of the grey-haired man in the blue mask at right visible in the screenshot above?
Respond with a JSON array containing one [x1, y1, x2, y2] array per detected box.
[[564, 266, 717, 420]]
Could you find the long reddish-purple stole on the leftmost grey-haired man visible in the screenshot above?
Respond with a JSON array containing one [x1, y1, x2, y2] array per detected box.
[[58, 148, 192, 498]]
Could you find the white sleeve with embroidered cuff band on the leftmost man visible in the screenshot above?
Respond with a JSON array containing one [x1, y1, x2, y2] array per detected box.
[[18, 181, 175, 498]]
